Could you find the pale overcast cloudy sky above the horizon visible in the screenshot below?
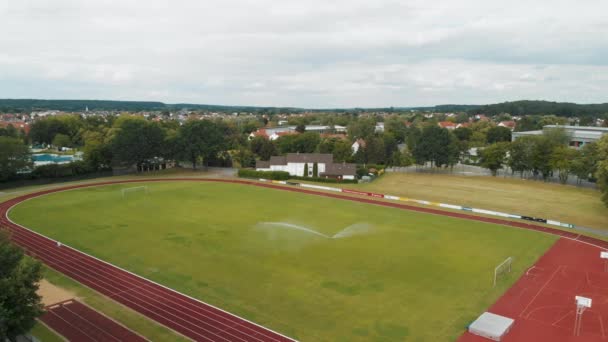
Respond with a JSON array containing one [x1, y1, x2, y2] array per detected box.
[[0, 0, 608, 108]]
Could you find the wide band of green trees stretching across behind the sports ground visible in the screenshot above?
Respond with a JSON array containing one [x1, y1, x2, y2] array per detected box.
[[0, 114, 608, 207]]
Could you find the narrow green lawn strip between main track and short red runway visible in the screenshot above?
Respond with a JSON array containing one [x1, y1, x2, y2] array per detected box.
[[44, 267, 188, 341]]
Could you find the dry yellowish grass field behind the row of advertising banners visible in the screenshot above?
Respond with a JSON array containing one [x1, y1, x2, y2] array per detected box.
[[340, 173, 608, 229]]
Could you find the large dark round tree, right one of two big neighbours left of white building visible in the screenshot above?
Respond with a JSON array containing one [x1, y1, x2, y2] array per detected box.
[[179, 120, 226, 169]]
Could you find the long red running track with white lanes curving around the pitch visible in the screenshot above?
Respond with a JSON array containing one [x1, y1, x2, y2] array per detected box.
[[0, 178, 608, 341]]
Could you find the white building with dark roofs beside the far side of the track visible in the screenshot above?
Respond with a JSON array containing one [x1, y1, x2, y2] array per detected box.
[[255, 153, 357, 179]]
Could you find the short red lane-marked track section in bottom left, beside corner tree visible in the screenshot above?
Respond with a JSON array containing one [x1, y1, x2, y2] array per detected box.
[[40, 299, 147, 342]]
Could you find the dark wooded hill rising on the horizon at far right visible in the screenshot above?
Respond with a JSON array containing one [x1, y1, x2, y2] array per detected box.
[[468, 101, 608, 117]]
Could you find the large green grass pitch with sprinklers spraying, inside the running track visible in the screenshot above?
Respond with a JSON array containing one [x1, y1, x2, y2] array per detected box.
[[10, 182, 555, 341]]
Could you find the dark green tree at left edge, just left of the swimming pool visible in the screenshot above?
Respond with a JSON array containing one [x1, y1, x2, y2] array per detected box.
[[0, 137, 32, 181]]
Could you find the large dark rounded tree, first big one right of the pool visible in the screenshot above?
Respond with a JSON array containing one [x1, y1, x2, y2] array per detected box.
[[111, 117, 164, 166]]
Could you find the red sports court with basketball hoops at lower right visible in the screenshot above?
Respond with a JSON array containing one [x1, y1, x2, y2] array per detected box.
[[458, 238, 608, 342]]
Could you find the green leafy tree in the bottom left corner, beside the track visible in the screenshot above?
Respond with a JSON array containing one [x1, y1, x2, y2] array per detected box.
[[0, 229, 43, 341]]
